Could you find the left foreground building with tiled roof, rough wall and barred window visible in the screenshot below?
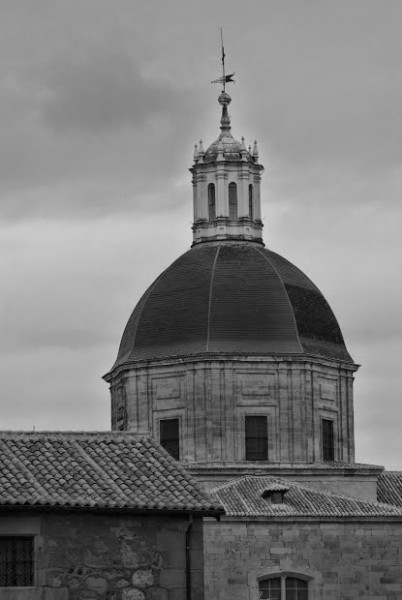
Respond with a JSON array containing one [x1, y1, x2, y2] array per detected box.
[[0, 432, 223, 600]]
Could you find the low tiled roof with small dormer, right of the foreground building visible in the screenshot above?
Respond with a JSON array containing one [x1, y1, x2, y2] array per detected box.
[[210, 476, 402, 519]]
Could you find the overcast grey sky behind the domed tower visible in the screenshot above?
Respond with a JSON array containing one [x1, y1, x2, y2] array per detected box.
[[0, 0, 402, 469]]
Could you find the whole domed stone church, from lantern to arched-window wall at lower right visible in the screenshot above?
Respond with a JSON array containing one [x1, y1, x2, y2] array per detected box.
[[105, 91, 402, 600]]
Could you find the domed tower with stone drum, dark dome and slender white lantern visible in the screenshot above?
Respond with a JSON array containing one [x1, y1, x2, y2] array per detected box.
[[105, 91, 357, 478]]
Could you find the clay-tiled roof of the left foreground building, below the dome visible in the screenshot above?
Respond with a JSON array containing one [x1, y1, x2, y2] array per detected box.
[[0, 432, 222, 514]]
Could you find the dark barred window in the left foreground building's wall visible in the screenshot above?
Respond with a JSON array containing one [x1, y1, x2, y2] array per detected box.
[[0, 537, 33, 587]]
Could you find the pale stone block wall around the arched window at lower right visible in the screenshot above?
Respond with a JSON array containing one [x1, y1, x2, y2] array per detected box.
[[204, 518, 402, 600]]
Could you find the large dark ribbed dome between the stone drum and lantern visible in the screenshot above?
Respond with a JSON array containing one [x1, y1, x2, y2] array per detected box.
[[113, 242, 353, 369]]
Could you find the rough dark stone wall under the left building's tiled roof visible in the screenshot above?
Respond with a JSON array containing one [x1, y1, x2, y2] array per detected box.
[[0, 513, 204, 600]]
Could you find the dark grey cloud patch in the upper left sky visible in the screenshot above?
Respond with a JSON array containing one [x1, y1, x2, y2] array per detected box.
[[42, 46, 177, 135]]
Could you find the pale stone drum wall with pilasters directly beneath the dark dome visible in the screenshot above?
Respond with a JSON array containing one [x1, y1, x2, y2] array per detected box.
[[110, 356, 354, 464]]
